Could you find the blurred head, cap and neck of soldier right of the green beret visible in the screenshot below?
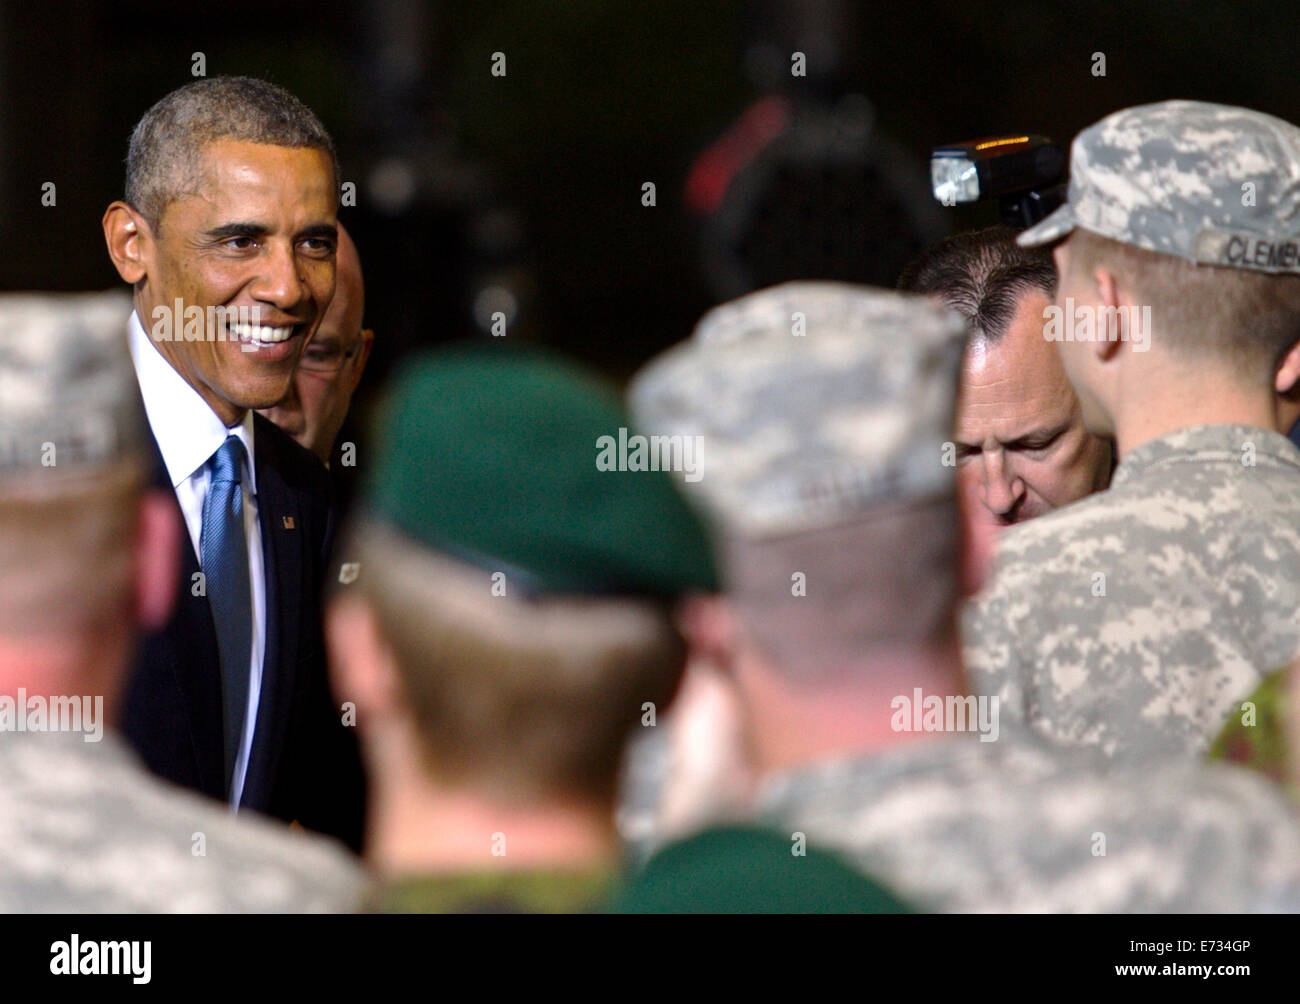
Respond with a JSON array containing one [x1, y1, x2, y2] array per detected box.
[[629, 282, 965, 769]]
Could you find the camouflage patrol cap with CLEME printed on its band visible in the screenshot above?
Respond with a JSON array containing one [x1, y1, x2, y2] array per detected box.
[[1019, 101, 1300, 273]]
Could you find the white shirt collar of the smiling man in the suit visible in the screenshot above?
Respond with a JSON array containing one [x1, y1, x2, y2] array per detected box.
[[131, 312, 257, 495]]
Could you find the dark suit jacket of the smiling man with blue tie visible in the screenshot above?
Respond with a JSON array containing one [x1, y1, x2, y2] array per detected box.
[[122, 415, 364, 851]]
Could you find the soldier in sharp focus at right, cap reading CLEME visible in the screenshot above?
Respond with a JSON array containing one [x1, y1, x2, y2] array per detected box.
[[966, 101, 1300, 760]]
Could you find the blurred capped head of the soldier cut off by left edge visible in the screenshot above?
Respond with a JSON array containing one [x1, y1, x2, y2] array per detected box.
[[0, 294, 179, 722]]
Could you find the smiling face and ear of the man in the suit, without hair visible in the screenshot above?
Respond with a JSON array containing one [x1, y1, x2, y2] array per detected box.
[[104, 139, 338, 427]]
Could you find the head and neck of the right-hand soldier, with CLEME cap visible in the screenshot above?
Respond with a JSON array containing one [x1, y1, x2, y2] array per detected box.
[[1019, 101, 1300, 453]]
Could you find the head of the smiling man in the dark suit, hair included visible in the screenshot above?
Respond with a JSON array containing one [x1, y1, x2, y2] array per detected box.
[[103, 77, 338, 425]]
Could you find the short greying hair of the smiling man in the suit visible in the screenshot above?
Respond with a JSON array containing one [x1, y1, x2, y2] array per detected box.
[[126, 77, 339, 231]]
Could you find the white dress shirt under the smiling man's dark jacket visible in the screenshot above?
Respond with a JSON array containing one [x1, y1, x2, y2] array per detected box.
[[131, 313, 267, 808]]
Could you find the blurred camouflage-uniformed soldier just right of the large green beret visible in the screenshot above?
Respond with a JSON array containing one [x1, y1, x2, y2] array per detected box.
[[629, 284, 1300, 912]]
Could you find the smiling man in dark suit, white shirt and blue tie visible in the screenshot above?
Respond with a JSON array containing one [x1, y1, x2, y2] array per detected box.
[[103, 77, 363, 848]]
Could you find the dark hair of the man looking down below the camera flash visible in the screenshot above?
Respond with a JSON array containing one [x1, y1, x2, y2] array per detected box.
[[898, 226, 1056, 342]]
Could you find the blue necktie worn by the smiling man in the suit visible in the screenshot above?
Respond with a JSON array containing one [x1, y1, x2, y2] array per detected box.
[[199, 436, 252, 784]]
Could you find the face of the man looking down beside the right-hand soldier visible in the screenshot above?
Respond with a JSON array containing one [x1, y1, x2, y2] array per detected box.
[[954, 290, 1112, 525]]
